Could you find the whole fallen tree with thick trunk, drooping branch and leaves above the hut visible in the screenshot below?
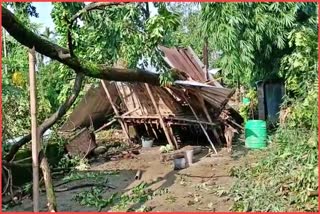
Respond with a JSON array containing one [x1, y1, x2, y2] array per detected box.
[[2, 3, 179, 161]]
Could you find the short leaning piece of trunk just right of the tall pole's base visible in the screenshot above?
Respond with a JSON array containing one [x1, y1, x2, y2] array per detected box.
[[40, 152, 57, 212]]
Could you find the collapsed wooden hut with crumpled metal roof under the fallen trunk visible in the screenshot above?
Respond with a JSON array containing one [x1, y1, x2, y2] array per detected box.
[[60, 46, 241, 155]]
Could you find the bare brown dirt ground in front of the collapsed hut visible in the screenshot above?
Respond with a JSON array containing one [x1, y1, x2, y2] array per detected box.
[[3, 143, 251, 211]]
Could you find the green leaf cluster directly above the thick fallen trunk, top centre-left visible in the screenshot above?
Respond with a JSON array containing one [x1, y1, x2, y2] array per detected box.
[[52, 3, 179, 71]]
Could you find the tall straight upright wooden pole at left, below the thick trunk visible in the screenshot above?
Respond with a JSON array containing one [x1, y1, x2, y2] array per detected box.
[[29, 47, 40, 212]]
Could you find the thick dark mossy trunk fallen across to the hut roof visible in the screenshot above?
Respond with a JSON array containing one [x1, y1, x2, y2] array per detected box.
[[2, 6, 159, 85]]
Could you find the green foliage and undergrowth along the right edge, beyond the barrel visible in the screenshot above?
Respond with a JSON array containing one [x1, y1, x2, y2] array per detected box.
[[230, 5, 318, 211]]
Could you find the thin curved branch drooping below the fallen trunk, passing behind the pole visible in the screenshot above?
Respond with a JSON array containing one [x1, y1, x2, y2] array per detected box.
[[4, 73, 84, 162]]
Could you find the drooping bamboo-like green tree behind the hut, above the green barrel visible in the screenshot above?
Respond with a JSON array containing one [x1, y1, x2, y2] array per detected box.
[[202, 3, 314, 86]]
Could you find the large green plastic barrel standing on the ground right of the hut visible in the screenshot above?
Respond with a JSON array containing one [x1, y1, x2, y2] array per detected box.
[[245, 120, 267, 149]]
